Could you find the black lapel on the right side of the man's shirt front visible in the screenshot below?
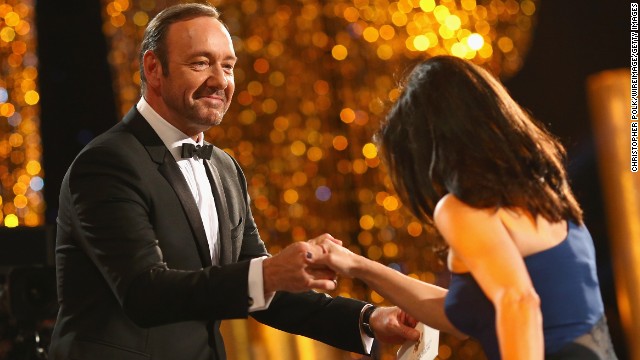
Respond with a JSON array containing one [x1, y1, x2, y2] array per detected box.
[[205, 153, 237, 265]]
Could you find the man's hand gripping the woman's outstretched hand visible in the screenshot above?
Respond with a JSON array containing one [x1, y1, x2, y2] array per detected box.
[[262, 234, 336, 294]]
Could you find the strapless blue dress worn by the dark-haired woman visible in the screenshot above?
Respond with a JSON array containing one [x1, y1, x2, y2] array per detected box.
[[445, 222, 604, 360]]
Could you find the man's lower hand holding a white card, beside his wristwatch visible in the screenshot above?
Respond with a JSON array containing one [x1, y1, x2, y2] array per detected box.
[[369, 306, 420, 344]]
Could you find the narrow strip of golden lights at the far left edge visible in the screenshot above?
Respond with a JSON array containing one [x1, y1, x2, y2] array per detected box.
[[0, 0, 45, 227]]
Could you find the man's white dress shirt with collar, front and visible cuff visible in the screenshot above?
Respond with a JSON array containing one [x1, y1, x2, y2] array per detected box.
[[136, 97, 274, 311]]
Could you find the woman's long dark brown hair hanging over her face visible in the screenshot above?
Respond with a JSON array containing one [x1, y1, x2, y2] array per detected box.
[[376, 56, 582, 224]]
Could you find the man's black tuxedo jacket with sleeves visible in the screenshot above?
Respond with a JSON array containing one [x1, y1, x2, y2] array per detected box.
[[50, 108, 364, 360]]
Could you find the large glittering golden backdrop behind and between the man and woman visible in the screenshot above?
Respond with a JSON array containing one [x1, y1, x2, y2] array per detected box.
[[103, 0, 537, 360]]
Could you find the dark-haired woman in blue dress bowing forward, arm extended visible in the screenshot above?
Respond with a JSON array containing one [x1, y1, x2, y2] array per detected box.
[[316, 56, 616, 359]]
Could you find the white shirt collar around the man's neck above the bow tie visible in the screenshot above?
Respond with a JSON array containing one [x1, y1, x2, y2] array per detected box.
[[136, 96, 204, 161]]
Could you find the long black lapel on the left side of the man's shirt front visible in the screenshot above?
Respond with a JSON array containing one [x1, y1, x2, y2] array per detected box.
[[123, 107, 211, 267]]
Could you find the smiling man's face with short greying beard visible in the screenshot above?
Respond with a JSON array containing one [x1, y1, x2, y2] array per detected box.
[[160, 17, 236, 135]]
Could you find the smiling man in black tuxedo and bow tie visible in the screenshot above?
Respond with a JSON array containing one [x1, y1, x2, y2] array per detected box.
[[50, 4, 418, 360]]
